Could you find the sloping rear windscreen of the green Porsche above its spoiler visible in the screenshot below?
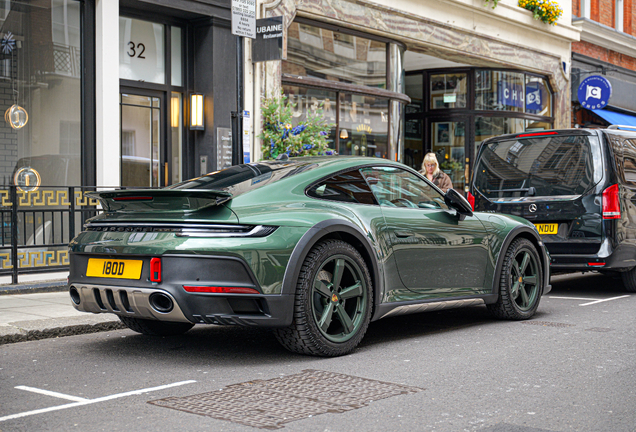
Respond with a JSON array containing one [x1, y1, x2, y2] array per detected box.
[[168, 161, 318, 197]]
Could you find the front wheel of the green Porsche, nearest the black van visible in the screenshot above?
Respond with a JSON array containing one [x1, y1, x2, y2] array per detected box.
[[488, 238, 543, 320]]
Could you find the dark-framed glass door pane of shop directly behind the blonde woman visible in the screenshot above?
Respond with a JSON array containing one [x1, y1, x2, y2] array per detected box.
[[428, 118, 470, 192]]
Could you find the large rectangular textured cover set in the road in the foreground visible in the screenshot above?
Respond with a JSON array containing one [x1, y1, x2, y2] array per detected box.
[[148, 370, 424, 429]]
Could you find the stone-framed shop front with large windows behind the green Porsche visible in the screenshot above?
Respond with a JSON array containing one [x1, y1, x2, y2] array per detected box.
[[254, 0, 578, 191]]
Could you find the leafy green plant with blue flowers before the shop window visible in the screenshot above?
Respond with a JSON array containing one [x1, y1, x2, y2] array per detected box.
[[258, 93, 336, 159]]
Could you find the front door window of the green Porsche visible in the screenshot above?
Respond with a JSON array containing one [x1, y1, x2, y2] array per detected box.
[[361, 167, 448, 210]]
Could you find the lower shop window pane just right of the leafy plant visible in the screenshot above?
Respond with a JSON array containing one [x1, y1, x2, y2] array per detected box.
[[338, 93, 389, 159]]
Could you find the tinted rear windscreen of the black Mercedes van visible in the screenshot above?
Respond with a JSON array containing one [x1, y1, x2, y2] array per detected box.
[[474, 135, 602, 198]]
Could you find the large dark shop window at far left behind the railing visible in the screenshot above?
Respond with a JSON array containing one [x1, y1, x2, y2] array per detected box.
[[0, 0, 82, 186]]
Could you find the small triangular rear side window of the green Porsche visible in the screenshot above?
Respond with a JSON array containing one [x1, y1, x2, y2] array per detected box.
[[307, 169, 378, 205]]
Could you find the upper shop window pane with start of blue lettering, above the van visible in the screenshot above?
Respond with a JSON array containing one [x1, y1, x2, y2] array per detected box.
[[475, 70, 525, 112]]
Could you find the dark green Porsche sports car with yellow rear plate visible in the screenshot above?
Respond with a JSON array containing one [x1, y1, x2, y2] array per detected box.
[[69, 157, 550, 356]]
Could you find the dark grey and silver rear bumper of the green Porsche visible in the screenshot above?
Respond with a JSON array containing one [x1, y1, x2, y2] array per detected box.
[[69, 253, 294, 327]]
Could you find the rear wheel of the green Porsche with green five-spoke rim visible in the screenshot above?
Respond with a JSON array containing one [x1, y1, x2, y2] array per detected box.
[[275, 240, 373, 357]]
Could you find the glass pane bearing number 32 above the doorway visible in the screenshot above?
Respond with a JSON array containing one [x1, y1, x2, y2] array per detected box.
[[119, 17, 166, 84]]
